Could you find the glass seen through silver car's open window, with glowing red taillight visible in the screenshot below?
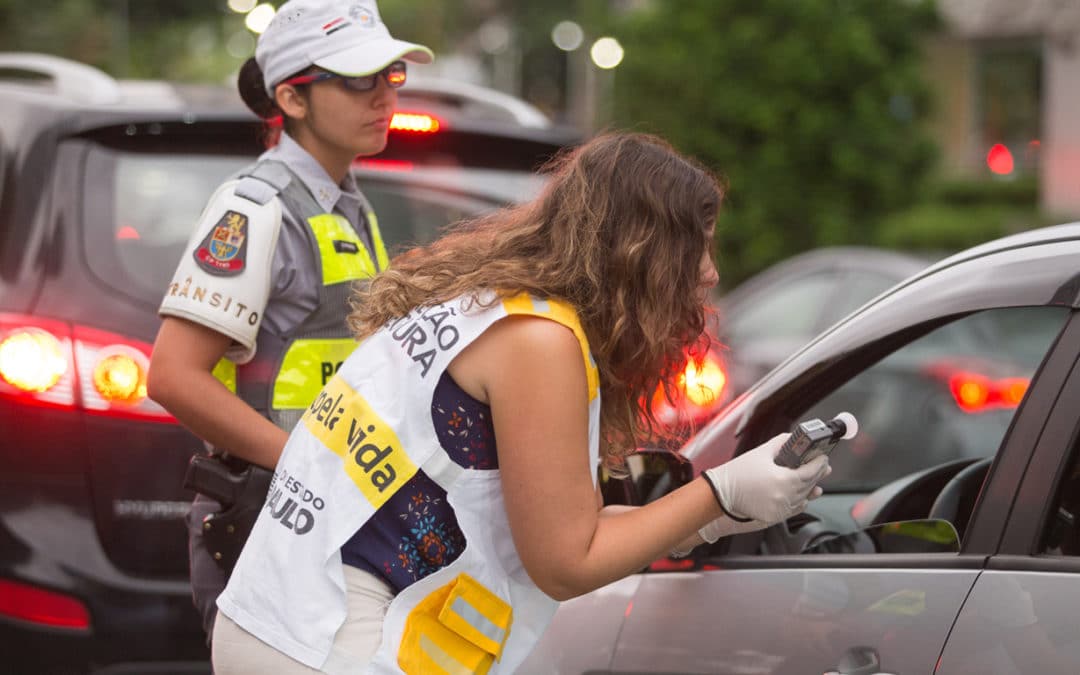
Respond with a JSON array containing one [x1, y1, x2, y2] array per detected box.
[[801, 307, 1068, 492]]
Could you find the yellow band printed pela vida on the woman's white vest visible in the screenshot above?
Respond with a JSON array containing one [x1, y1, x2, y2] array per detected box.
[[300, 377, 417, 510]]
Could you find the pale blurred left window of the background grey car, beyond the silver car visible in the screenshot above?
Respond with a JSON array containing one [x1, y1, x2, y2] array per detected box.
[[724, 273, 839, 345]]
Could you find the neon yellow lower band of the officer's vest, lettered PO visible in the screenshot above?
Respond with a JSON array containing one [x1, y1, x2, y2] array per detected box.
[[270, 338, 356, 410]]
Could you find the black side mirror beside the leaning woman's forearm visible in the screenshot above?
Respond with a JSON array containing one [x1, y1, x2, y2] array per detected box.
[[599, 449, 693, 507]]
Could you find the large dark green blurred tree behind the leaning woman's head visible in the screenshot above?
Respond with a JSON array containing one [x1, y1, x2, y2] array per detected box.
[[615, 0, 936, 287]]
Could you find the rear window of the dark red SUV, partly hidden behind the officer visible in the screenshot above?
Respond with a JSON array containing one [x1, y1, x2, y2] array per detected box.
[[99, 152, 535, 300]]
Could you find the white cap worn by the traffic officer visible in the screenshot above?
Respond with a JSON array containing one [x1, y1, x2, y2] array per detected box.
[[255, 0, 434, 98]]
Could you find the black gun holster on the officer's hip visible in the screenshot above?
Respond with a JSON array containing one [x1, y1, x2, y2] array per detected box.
[[184, 455, 273, 573]]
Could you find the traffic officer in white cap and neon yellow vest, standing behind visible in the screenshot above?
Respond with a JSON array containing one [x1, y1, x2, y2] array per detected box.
[[149, 0, 432, 635]]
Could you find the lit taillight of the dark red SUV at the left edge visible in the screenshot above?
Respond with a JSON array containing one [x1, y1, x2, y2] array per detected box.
[[0, 314, 176, 423]]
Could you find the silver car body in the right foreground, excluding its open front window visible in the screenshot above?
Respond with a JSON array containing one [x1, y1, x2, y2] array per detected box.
[[540, 224, 1080, 674]]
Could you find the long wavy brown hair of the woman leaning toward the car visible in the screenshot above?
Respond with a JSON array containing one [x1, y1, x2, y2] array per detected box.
[[349, 133, 724, 468]]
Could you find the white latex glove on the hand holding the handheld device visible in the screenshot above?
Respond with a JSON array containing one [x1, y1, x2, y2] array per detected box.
[[704, 433, 829, 526]]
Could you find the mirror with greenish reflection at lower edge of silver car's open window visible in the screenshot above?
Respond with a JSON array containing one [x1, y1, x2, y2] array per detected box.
[[802, 519, 960, 553]]
